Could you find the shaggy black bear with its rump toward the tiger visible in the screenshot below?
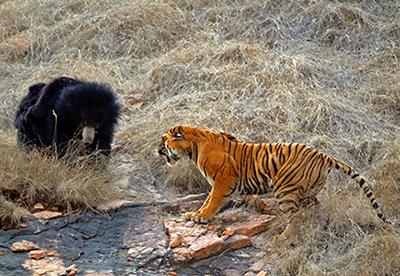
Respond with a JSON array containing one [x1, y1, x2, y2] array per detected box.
[[14, 77, 121, 158]]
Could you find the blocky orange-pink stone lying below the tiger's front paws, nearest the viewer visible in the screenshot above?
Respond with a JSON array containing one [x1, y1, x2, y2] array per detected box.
[[189, 234, 224, 260]]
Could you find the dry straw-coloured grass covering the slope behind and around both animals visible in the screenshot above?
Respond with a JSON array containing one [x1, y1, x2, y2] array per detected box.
[[0, 0, 400, 275]]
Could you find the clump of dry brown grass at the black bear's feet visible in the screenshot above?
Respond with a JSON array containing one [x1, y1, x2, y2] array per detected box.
[[0, 132, 118, 225]]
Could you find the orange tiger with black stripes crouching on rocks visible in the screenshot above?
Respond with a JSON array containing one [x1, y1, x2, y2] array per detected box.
[[158, 126, 390, 240]]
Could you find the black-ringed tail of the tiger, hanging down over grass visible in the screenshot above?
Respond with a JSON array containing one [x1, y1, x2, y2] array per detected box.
[[327, 156, 391, 224]]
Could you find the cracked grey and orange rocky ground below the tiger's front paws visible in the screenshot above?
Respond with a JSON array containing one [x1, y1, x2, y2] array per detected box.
[[0, 193, 275, 276]]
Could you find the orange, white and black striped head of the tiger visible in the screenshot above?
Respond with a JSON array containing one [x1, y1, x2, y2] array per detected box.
[[158, 126, 192, 166]]
